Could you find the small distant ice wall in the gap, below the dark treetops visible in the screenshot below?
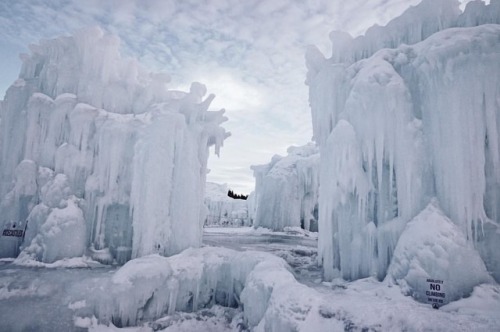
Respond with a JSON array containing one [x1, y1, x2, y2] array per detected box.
[[205, 182, 252, 226]]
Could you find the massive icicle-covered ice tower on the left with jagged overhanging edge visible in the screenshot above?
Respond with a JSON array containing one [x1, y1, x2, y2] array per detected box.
[[0, 28, 229, 263]]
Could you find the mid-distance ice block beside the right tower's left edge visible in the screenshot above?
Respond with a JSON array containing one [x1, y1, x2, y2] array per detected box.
[[252, 143, 319, 230]]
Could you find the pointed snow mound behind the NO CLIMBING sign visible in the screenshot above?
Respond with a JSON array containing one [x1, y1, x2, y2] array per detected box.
[[387, 201, 493, 303]]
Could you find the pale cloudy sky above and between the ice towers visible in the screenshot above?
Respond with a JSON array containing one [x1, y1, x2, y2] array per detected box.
[[0, 0, 474, 193]]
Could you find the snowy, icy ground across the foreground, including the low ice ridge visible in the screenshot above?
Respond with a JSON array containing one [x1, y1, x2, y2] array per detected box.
[[0, 228, 500, 331]]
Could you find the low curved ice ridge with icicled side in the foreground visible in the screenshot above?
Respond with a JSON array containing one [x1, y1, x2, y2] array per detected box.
[[77, 247, 332, 331]]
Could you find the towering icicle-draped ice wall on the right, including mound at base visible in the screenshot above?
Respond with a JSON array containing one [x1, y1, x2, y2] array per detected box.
[[306, 0, 500, 298]]
